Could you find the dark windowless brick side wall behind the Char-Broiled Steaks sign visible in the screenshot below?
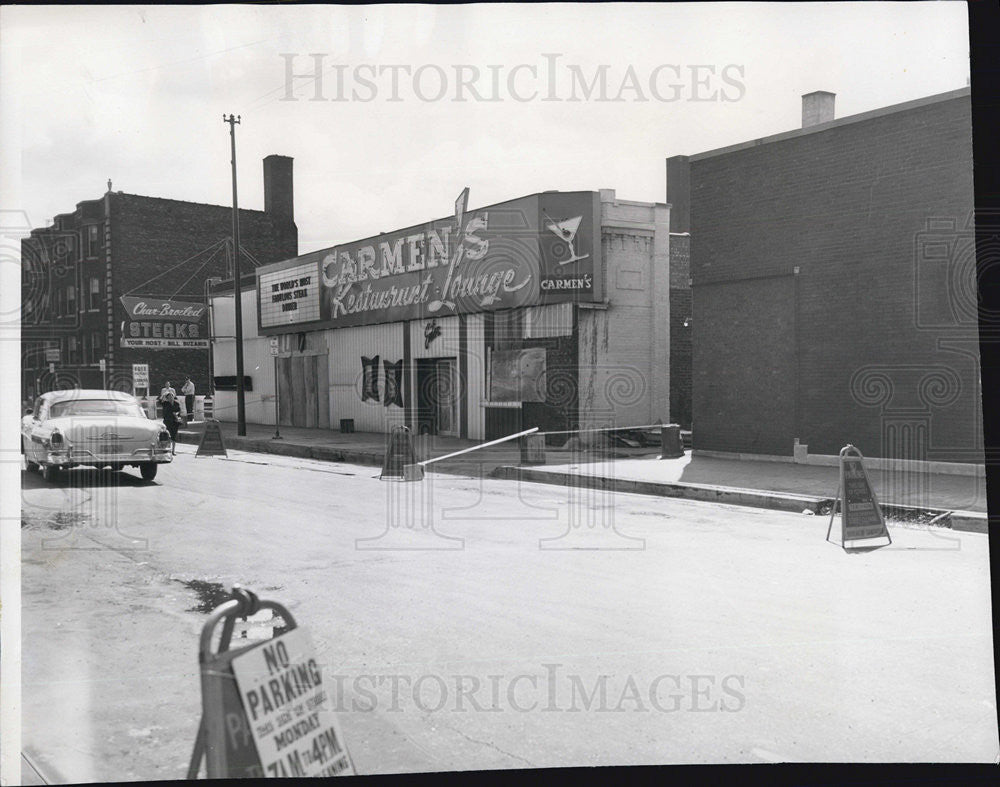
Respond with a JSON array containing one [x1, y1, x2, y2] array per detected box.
[[111, 194, 298, 394]]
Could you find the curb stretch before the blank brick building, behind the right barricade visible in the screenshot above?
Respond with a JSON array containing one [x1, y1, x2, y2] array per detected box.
[[490, 465, 989, 533]]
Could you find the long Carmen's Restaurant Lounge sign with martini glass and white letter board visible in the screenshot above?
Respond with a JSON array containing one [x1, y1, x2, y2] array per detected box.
[[257, 191, 604, 334]]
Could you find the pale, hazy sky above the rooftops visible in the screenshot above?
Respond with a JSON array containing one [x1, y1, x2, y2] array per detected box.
[[0, 2, 969, 253]]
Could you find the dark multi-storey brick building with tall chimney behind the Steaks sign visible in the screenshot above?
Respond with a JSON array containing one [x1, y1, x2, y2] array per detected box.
[[21, 156, 298, 398]]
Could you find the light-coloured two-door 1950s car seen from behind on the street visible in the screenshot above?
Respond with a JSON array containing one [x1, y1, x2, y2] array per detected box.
[[21, 389, 173, 481]]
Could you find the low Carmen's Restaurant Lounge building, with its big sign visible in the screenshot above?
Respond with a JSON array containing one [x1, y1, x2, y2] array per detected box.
[[213, 189, 671, 444]]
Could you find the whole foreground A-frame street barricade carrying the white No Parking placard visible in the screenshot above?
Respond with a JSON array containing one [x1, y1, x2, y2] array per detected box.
[[187, 588, 354, 779]]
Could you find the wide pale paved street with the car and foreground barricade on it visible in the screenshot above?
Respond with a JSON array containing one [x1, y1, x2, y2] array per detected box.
[[22, 446, 998, 781]]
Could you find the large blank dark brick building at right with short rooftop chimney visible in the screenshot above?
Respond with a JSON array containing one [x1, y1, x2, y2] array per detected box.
[[667, 88, 983, 464]]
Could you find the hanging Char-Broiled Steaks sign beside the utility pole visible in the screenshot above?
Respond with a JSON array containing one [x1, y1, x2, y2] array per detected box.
[[121, 295, 208, 350]]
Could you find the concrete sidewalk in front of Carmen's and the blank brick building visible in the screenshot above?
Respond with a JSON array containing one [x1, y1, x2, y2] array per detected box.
[[178, 422, 987, 532]]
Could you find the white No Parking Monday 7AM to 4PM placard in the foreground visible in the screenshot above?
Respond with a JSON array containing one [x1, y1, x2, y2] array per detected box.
[[232, 628, 354, 778]]
